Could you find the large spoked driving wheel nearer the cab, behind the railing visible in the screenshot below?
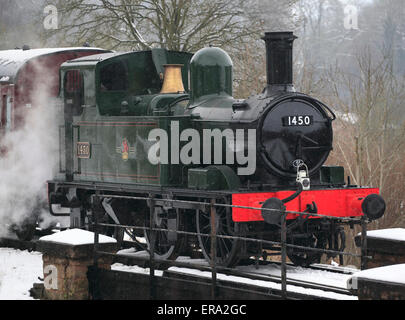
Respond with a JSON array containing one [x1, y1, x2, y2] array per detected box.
[[144, 212, 185, 260]]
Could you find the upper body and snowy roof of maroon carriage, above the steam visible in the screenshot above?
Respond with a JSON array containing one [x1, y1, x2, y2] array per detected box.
[[0, 47, 107, 136]]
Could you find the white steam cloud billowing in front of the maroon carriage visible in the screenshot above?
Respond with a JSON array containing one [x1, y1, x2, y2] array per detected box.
[[0, 65, 61, 237]]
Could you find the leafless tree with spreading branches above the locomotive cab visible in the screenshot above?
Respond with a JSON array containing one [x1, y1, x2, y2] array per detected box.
[[44, 0, 270, 51]]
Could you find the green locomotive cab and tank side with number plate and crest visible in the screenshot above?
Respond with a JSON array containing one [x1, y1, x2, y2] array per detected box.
[[56, 49, 192, 185]]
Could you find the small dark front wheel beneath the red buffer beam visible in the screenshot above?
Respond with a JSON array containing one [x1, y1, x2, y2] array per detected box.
[[287, 235, 326, 267]]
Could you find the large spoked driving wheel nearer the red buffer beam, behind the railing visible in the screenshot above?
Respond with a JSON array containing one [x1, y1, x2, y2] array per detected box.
[[197, 202, 244, 267]]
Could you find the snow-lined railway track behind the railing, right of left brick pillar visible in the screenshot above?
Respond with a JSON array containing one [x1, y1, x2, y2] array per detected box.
[[109, 252, 356, 300]]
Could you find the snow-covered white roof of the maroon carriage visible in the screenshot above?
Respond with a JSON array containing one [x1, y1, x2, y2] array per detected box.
[[0, 47, 104, 81]]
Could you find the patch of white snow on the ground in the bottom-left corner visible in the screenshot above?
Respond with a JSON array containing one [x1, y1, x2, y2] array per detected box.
[[0, 248, 43, 300]]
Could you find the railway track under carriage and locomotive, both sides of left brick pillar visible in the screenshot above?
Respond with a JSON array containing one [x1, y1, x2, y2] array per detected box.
[[0, 238, 356, 300]]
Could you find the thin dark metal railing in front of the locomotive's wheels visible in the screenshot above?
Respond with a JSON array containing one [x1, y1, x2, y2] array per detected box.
[[92, 192, 370, 300]]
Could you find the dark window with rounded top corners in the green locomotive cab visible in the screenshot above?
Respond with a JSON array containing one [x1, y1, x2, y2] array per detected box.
[[100, 62, 128, 91]]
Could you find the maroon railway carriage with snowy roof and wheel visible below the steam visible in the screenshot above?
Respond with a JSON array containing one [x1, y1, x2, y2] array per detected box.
[[0, 47, 108, 240]]
